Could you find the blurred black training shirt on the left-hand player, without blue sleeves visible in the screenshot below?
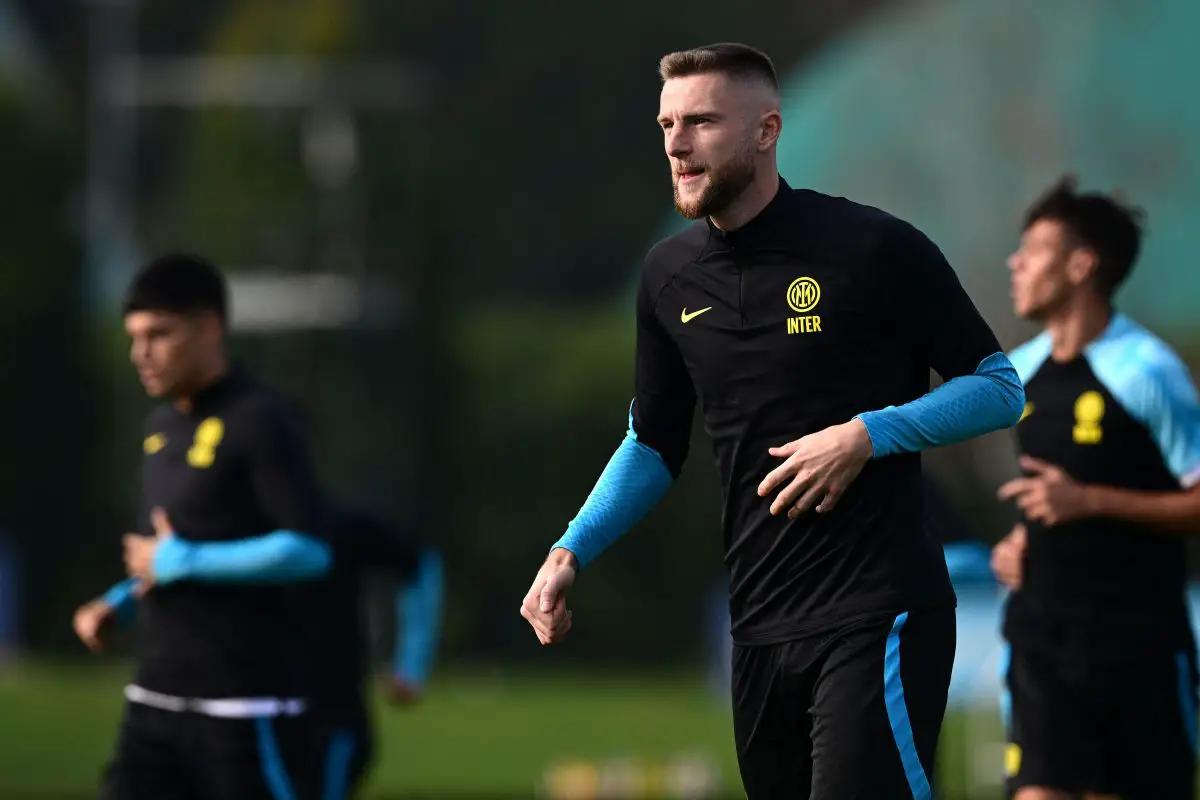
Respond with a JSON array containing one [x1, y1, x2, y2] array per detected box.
[[136, 372, 323, 698]]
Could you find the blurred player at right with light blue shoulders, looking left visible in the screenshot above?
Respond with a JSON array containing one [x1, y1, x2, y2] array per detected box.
[[994, 178, 1200, 800]]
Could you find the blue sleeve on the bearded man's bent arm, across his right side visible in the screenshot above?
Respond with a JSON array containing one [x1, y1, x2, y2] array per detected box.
[[856, 353, 1025, 458]]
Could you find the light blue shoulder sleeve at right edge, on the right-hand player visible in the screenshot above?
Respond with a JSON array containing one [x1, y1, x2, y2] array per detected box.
[[1086, 318, 1200, 488]]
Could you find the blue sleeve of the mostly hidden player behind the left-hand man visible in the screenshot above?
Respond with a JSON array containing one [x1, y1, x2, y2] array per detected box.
[[392, 551, 444, 686]]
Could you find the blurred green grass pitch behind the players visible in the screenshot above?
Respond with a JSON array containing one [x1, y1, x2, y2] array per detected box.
[[0, 664, 1000, 800]]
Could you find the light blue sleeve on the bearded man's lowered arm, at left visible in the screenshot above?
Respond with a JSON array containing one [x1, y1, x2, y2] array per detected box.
[[552, 413, 674, 567]]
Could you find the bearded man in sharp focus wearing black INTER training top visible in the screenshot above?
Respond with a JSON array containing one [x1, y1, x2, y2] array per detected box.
[[521, 44, 1024, 800]]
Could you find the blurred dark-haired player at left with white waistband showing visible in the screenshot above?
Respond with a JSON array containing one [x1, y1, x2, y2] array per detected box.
[[91, 255, 331, 800]]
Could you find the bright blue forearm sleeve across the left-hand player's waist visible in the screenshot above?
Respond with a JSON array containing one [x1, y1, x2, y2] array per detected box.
[[154, 530, 334, 583]]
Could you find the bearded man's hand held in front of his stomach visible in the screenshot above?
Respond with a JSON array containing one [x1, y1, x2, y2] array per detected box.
[[758, 420, 872, 519]]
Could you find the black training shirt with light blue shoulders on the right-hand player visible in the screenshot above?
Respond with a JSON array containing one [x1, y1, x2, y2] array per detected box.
[[1004, 314, 1200, 660]]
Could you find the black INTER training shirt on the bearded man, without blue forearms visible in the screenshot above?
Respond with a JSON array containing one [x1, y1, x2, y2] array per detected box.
[[632, 180, 1000, 644]]
